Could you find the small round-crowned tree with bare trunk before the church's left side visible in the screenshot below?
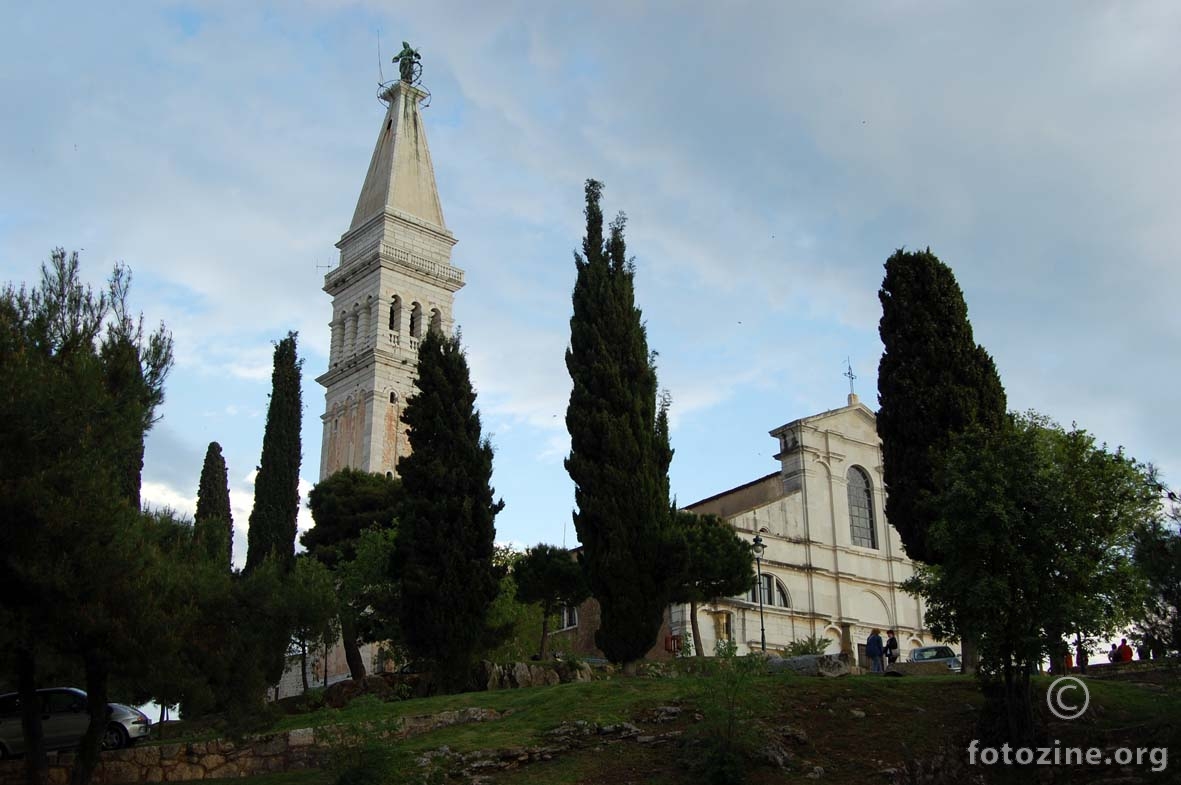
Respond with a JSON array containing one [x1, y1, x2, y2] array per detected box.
[[672, 510, 755, 656]]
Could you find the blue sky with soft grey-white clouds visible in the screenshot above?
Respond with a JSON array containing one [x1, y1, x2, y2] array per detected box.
[[0, 0, 1181, 564]]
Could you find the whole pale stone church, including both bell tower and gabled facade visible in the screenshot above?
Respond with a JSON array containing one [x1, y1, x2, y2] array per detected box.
[[275, 65, 931, 698]]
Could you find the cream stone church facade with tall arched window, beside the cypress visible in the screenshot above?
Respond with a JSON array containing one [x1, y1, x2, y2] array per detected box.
[[670, 394, 933, 662]]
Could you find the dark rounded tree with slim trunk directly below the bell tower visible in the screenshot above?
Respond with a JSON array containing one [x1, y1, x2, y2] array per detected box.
[[300, 469, 402, 679]]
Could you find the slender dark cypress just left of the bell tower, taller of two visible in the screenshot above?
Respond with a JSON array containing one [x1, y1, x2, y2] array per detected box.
[[246, 333, 304, 573]]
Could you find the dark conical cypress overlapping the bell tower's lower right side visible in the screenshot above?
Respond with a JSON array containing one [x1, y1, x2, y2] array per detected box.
[[398, 329, 504, 689]]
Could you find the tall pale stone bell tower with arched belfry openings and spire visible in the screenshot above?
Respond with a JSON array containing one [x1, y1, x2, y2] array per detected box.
[[317, 77, 463, 479]]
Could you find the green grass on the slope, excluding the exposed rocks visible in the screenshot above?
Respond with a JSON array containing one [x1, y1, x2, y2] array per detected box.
[[177, 674, 1181, 785]]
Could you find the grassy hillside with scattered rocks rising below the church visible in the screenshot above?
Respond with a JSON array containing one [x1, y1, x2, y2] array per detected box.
[[177, 672, 1181, 785]]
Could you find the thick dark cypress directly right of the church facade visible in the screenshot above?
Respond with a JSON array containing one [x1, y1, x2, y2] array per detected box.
[[877, 249, 1005, 563]]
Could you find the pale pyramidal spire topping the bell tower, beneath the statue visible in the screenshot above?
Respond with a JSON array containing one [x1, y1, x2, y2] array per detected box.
[[348, 81, 446, 231]]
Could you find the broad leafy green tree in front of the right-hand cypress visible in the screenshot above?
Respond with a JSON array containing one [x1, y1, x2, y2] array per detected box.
[[906, 416, 1159, 741]]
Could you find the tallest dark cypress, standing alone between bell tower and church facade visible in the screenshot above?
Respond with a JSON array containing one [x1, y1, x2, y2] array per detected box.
[[566, 179, 683, 665]]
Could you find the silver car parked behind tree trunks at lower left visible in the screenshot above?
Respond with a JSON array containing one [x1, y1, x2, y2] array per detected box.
[[0, 687, 151, 758]]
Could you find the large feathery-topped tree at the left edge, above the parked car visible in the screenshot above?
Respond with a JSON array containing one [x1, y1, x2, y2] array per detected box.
[[0, 249, 172, 783]]
